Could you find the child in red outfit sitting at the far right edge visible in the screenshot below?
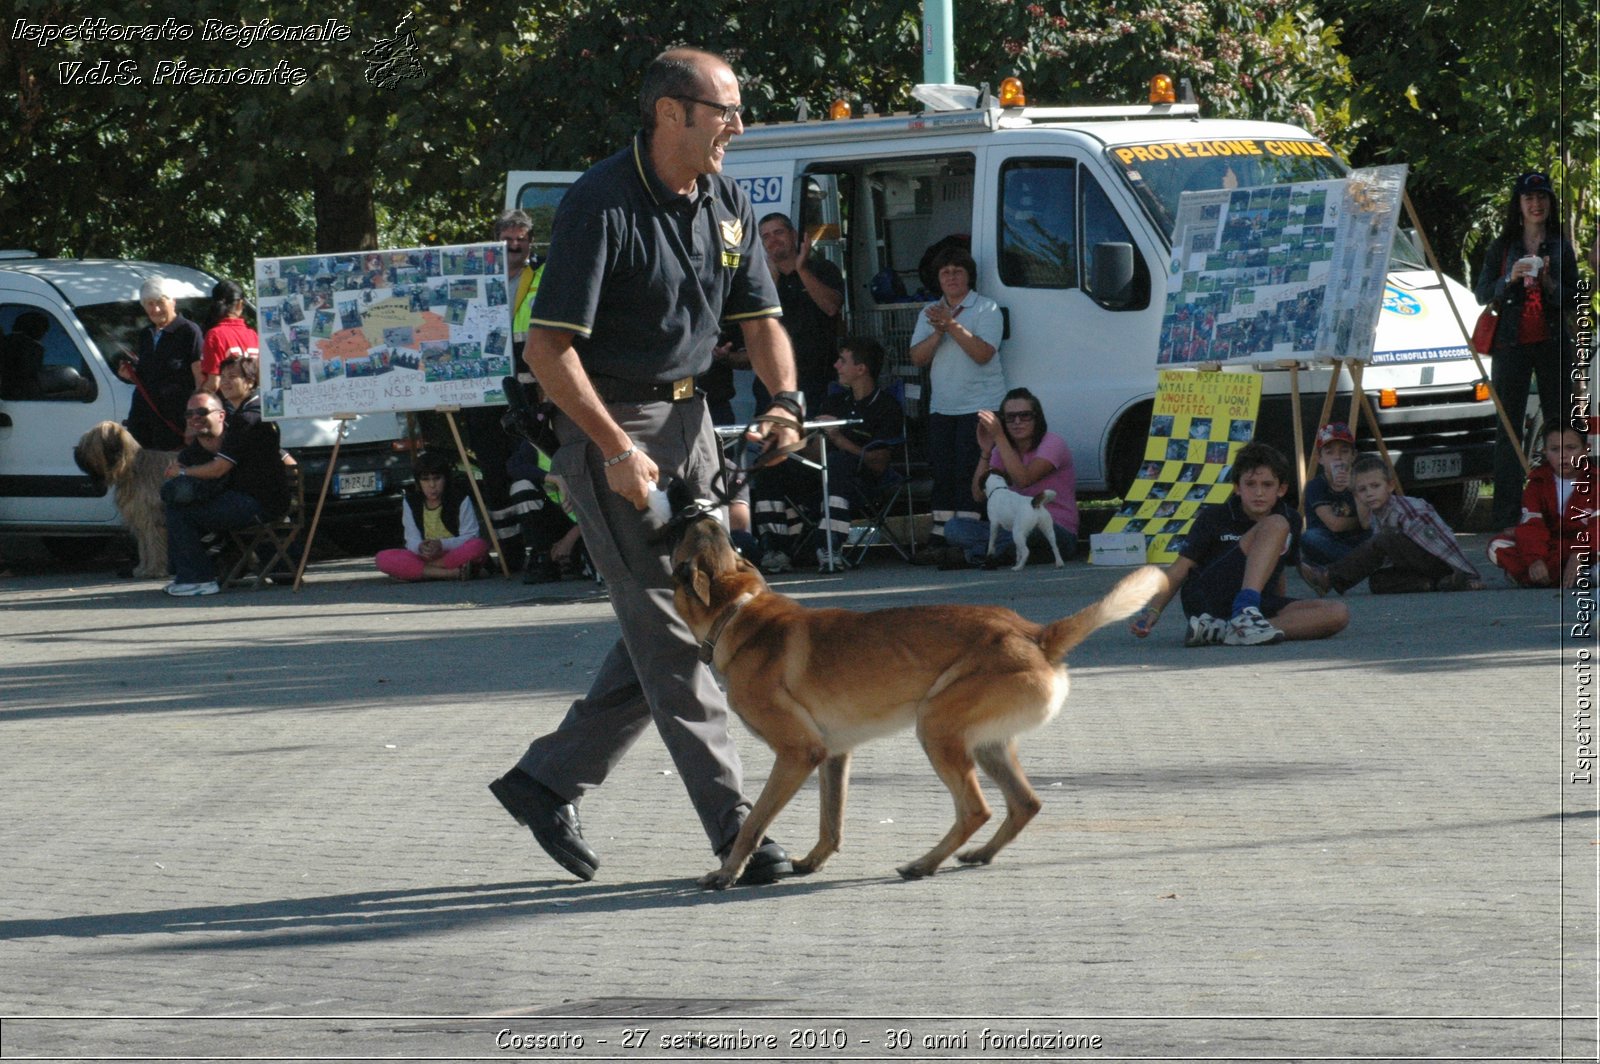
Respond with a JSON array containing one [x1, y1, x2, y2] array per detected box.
[[1490, 422, 1600, 587]]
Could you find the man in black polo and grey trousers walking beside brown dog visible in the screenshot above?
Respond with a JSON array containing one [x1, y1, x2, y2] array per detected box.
[[490, 48, 805, 883]]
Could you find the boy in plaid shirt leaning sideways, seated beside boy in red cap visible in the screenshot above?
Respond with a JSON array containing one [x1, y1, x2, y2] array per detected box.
[[1301, 454, 1483, 595]]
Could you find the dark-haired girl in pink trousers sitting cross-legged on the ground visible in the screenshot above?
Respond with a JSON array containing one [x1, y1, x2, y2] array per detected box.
[[378, 451, 490, 581]]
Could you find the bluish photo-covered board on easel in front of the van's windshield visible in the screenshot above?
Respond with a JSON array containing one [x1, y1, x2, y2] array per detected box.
[[1157, 165, 1405, 366]]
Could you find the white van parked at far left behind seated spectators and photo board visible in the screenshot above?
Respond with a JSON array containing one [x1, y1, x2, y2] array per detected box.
[[0, 251, 411, 536]]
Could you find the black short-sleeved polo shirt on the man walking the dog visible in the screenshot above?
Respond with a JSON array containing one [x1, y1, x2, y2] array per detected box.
[[530, 133, 781, 382]]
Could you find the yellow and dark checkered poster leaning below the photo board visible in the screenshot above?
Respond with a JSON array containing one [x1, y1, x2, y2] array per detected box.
[[1106, 370, 1261, 565]]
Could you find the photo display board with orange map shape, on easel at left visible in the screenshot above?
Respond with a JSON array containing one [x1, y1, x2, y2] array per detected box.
[[256, 243, 512, 418]]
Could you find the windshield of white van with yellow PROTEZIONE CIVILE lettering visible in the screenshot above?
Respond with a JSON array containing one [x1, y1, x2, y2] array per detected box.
[[1106, 138, 1347, 246]]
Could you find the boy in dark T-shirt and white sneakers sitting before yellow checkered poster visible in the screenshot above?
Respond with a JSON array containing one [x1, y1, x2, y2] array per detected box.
[[1133, 443, 1350, 646]]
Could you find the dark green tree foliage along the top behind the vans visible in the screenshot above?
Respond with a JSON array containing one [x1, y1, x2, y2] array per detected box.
[[0, 0, 1600, 286]]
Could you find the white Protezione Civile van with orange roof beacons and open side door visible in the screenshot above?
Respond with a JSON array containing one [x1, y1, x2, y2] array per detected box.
[[507, 86, 1494, 509]]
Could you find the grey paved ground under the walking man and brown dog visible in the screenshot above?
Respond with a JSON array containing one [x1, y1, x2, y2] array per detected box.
[[0, 536, 1600, 1061]]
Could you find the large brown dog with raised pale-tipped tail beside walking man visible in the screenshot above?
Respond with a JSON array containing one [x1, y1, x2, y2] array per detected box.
[[672, 517, 1162, 890]]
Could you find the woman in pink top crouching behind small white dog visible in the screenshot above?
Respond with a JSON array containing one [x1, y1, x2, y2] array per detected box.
[[944, 387, 1078, 568]]
